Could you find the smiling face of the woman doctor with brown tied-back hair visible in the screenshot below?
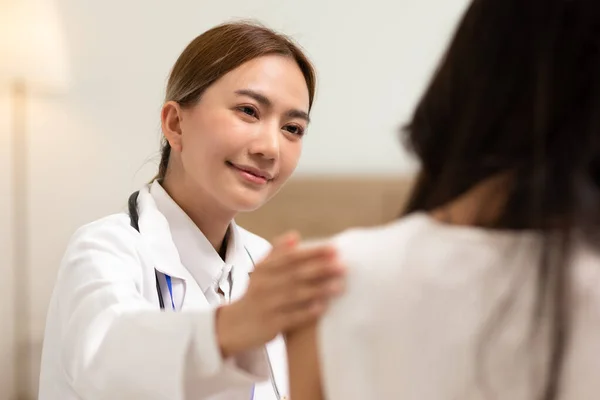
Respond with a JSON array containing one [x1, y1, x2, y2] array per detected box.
[[169, 55, 309, 212]]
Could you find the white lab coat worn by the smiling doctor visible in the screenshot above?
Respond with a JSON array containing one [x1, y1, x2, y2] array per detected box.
[[39, 184, 288, 400]]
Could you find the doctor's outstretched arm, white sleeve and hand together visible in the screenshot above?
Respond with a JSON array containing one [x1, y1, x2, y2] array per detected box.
[[61, 225, 341, 400]]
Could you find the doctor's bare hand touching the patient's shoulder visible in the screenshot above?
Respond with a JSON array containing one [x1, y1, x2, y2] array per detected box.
[[216, 233, 345, 357]]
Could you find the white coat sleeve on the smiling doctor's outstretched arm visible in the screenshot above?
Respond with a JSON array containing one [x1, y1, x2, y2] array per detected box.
[[55, 222, 255, 400]]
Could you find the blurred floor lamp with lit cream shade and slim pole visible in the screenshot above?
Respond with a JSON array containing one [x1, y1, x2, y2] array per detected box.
[[0, 0, 67, 399]]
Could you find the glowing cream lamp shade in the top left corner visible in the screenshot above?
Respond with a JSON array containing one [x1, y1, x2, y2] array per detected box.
[[0, 0, 68, 92]]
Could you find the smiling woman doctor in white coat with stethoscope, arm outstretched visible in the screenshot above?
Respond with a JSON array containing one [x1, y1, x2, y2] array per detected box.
[[39, 23, 343, 400]]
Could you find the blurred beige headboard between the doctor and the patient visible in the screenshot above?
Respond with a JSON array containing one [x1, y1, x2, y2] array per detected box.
[[236, 176, 412, 240]]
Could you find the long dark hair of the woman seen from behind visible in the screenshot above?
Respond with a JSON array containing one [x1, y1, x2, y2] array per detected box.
[[405, 0, 600, 400]]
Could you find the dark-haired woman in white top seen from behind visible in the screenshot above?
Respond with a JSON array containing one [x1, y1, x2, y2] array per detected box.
[[287, 0, 600, 400]]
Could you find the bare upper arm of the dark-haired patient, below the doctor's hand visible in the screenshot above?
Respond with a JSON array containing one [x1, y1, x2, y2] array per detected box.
[[286, 324, 324, 400]]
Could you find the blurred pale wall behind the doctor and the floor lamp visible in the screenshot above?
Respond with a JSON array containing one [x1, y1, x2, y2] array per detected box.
[[0, 0, 466, 398]]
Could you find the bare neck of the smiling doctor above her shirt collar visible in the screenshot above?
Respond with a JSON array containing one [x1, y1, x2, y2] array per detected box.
[[160, 176, 236, 256]]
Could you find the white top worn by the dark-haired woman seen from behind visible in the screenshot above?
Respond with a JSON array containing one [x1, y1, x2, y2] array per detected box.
[[319, 214, 600, 400]]
